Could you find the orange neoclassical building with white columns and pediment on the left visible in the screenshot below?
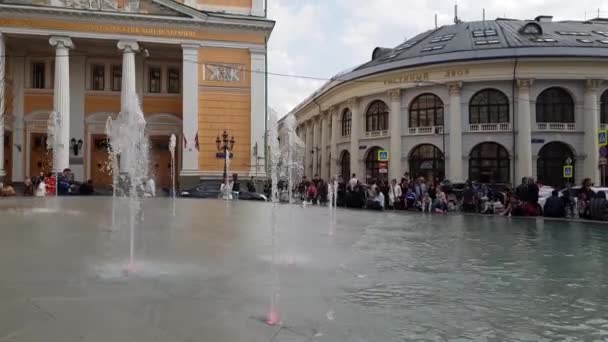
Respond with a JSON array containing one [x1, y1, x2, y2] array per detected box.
[[0, 0, 274, 186]]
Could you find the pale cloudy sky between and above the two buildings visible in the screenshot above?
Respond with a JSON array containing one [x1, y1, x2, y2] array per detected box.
[[268, 0, 608, 117]]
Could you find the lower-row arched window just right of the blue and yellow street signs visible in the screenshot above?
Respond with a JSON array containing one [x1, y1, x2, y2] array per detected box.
[[409, 144, 445, 180]]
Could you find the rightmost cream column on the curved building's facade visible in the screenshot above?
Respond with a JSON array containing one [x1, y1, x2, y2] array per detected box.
[[577, 80, 601, 184]]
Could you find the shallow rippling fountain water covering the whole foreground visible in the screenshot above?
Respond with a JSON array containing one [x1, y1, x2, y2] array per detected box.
[[0, 198, 608, 342]]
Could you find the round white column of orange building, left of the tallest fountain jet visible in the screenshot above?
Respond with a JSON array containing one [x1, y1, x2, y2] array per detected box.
[[49, 37, 74, 173]]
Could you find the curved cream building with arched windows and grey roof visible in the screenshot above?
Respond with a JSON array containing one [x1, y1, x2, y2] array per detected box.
[[292, 16, 608, 185]]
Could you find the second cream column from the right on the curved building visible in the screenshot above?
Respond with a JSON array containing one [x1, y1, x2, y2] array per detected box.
[[513, 79, 533, 184]]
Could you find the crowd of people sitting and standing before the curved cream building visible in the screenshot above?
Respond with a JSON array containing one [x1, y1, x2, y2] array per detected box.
[[294, 173, 608, 221]]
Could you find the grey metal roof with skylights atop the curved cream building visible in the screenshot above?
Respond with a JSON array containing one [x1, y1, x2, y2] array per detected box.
[[350, 16, 608, 79]]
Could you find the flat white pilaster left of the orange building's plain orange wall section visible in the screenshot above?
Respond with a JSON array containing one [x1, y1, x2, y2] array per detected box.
[[180, 45, 199, 176]]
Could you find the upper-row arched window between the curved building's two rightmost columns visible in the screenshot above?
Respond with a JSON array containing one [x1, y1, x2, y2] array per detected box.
[[536, 87, 574, 123]]
